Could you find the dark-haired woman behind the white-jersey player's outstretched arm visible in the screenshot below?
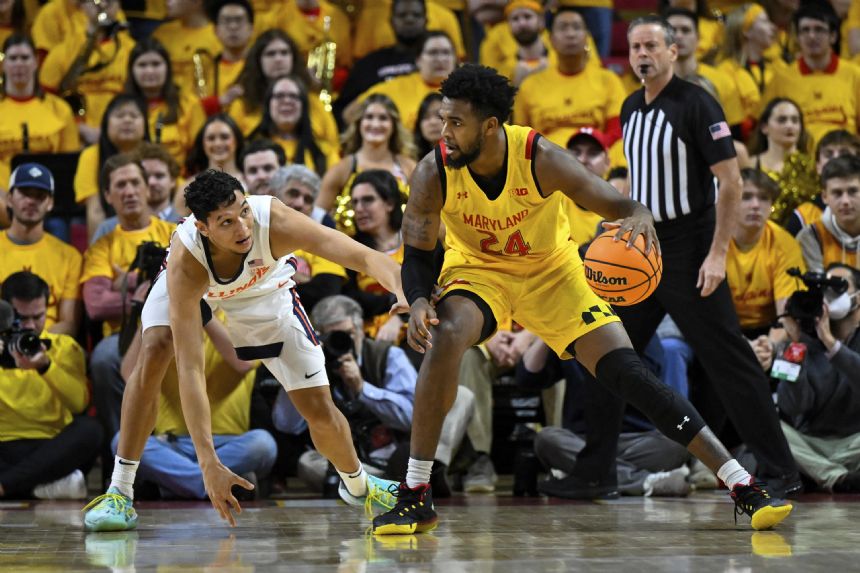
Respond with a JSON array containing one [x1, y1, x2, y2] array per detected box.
[[344, 169, 405, 344]]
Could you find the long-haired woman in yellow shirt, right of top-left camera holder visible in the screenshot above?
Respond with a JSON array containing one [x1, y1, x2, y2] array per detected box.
[[125, 38, 206, 170]]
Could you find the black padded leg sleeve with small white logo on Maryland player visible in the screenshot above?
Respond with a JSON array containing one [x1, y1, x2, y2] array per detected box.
[[595, 348, 705, 447]]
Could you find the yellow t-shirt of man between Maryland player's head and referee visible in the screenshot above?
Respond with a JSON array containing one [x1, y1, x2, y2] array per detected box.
[[514, 66, 627, 147]]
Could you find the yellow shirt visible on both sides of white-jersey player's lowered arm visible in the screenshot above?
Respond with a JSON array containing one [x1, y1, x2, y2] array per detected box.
[[155, 328, 256, 436]]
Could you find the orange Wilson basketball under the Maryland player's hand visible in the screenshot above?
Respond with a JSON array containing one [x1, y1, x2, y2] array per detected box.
[[583, 229, 663, 306]]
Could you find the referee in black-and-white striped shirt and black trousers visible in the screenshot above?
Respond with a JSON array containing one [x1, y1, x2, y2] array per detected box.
[[571, 16, 802, 497]]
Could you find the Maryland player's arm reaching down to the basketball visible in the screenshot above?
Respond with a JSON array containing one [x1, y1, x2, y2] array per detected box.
[[535, 137, 660, 252]]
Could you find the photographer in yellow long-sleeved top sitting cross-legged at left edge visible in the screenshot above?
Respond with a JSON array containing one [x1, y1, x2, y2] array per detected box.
[[0, 272, 102, 499]]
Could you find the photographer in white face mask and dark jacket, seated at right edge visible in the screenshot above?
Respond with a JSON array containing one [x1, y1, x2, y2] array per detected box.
[[775, 263, 860, 492]]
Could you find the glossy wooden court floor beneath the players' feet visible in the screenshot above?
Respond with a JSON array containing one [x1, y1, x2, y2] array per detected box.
[[0, 493, 860, 573]]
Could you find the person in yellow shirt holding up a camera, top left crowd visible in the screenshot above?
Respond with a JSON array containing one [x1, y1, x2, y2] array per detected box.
[[39, 0, 134, 144]]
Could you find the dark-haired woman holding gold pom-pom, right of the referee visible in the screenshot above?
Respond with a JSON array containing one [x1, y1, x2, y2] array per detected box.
[[750, 98, 818, 224]]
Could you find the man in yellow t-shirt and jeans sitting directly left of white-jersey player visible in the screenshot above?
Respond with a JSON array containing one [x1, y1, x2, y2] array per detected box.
[[81, 154, 174, 436]]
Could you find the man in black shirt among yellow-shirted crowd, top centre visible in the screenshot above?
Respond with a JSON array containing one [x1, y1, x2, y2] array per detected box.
[[334, 0, 427, 123]]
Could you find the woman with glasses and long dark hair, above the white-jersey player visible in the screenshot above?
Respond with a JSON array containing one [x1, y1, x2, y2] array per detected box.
[[248, 76, 339, 177]]
